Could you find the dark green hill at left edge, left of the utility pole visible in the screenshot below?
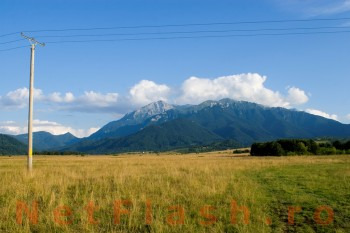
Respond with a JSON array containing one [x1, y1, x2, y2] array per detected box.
[[0, 134, 27, 155]]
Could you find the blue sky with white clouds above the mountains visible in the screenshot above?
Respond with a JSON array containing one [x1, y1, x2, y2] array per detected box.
[[0, 0, 350, 137]]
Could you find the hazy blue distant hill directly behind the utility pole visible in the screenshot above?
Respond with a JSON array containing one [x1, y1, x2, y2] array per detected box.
[[13, 131, 79, 151]]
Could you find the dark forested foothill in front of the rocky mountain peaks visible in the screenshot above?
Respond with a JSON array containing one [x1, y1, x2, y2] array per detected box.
[[66, 119, 222, 154]]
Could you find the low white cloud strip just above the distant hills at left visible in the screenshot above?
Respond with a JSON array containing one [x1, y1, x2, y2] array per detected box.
[[0, 119, 100, 138]]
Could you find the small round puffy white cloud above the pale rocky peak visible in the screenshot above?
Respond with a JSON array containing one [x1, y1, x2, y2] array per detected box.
[[129, 80, 170, 106]]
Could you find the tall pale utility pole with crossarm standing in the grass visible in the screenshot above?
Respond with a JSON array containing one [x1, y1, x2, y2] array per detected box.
[[21, 32, 45, 172]]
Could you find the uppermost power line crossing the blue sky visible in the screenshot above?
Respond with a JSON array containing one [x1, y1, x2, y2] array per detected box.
[[0, 17, 350, 37]]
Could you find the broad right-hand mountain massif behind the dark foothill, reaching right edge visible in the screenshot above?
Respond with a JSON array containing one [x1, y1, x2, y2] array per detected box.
[[144, 99, 350, 145]]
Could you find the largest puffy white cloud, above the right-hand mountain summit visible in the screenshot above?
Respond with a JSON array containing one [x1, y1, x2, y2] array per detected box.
[[177, 73, 308, 107]]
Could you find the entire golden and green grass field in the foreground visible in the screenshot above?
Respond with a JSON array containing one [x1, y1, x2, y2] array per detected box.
[[0, 152, 350, 232]]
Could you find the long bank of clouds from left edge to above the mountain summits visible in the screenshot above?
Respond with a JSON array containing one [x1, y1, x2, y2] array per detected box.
[[0, 73, 309, 114]]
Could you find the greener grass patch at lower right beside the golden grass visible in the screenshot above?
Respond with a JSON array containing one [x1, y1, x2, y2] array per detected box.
[[250, 160, 350, 232]]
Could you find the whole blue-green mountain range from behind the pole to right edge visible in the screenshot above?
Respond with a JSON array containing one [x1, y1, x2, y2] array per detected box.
[[0, 99, 350, 154]]
